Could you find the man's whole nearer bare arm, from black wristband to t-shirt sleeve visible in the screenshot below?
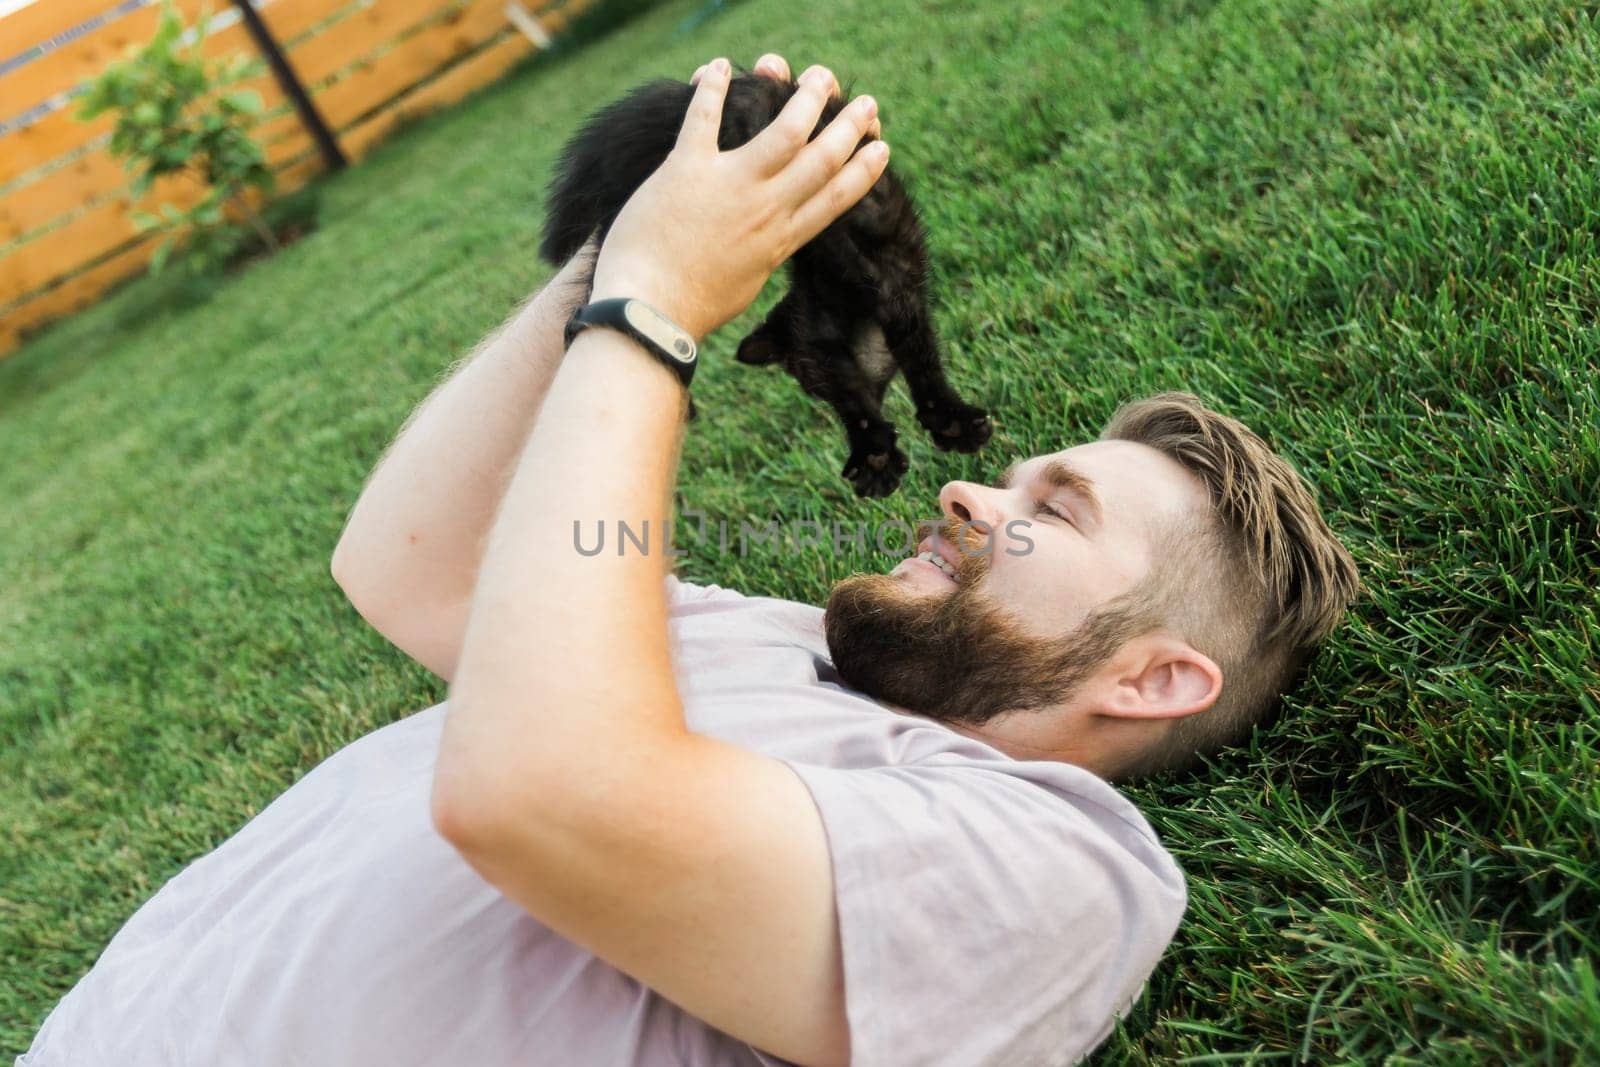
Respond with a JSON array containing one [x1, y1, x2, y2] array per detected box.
[[430, 330, 848, 1064]]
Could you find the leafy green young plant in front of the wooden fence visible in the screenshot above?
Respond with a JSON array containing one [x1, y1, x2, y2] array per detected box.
[[78, 0, 278, 274]]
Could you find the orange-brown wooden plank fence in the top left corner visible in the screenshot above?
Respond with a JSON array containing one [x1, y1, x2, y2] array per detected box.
[[0, 0, 594, 355]]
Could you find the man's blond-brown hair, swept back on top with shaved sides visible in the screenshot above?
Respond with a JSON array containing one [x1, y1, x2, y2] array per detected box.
[[1101, 392, 1360, 773]]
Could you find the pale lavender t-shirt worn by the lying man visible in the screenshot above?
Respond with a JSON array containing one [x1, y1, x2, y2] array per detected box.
[[18, 579, 1184, 1067]]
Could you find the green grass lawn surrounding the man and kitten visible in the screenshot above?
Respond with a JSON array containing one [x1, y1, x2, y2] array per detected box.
[[0, 0, 1600, 1064]]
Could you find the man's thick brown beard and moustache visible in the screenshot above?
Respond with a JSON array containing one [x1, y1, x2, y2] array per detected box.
[[824, 523, 1154, 726]]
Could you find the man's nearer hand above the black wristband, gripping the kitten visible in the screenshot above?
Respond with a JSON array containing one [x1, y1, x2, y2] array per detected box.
[[594, 58, 890, 338]]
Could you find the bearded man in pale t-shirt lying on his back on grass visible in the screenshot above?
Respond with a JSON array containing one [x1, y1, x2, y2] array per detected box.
[[24, 58, 1355, 1067]]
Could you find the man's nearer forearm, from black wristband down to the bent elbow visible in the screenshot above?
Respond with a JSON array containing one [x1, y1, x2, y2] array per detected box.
[[437, 330, 683, 808]]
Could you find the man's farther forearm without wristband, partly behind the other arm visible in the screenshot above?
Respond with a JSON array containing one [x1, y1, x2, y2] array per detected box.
[[333, 254, 589, 678]]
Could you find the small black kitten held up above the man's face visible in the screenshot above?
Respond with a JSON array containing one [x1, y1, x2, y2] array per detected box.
[[539, 74, 990, 496]]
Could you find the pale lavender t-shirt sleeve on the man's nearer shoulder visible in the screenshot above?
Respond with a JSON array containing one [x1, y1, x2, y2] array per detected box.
[[780, 763, 1186, 1067]]
